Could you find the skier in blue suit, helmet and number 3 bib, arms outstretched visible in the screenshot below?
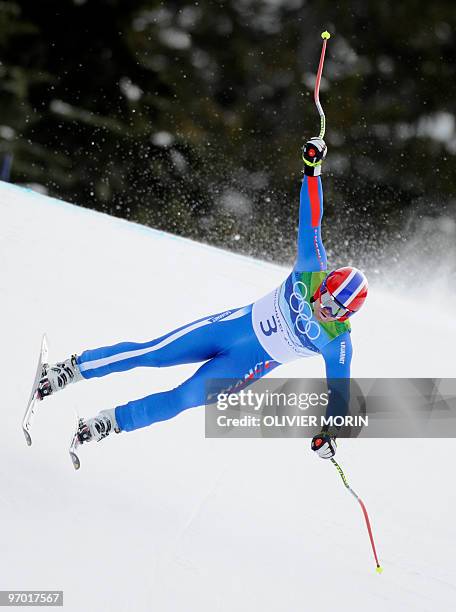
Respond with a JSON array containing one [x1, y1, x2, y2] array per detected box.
[[38, 137, 367, 458]]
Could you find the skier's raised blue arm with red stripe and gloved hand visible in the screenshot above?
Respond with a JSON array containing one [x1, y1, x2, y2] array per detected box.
[[294, 139, 327, 272]]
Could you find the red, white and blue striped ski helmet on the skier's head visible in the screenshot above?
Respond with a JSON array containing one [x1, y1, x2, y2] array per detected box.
[[313, 266, 368, 321]]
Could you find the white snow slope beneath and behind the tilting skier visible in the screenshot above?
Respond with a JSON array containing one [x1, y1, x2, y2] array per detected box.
[[0, 184, 456, 612]]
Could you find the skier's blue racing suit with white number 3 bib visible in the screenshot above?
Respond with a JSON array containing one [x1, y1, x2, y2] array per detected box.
[[77, 176, 352, 431]]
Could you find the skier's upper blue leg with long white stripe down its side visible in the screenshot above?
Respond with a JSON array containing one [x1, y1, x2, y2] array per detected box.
[[77, 306, 251, 378]]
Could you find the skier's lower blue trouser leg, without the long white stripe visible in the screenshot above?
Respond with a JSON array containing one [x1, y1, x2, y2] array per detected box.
[[115, 323, 278, 431]]
